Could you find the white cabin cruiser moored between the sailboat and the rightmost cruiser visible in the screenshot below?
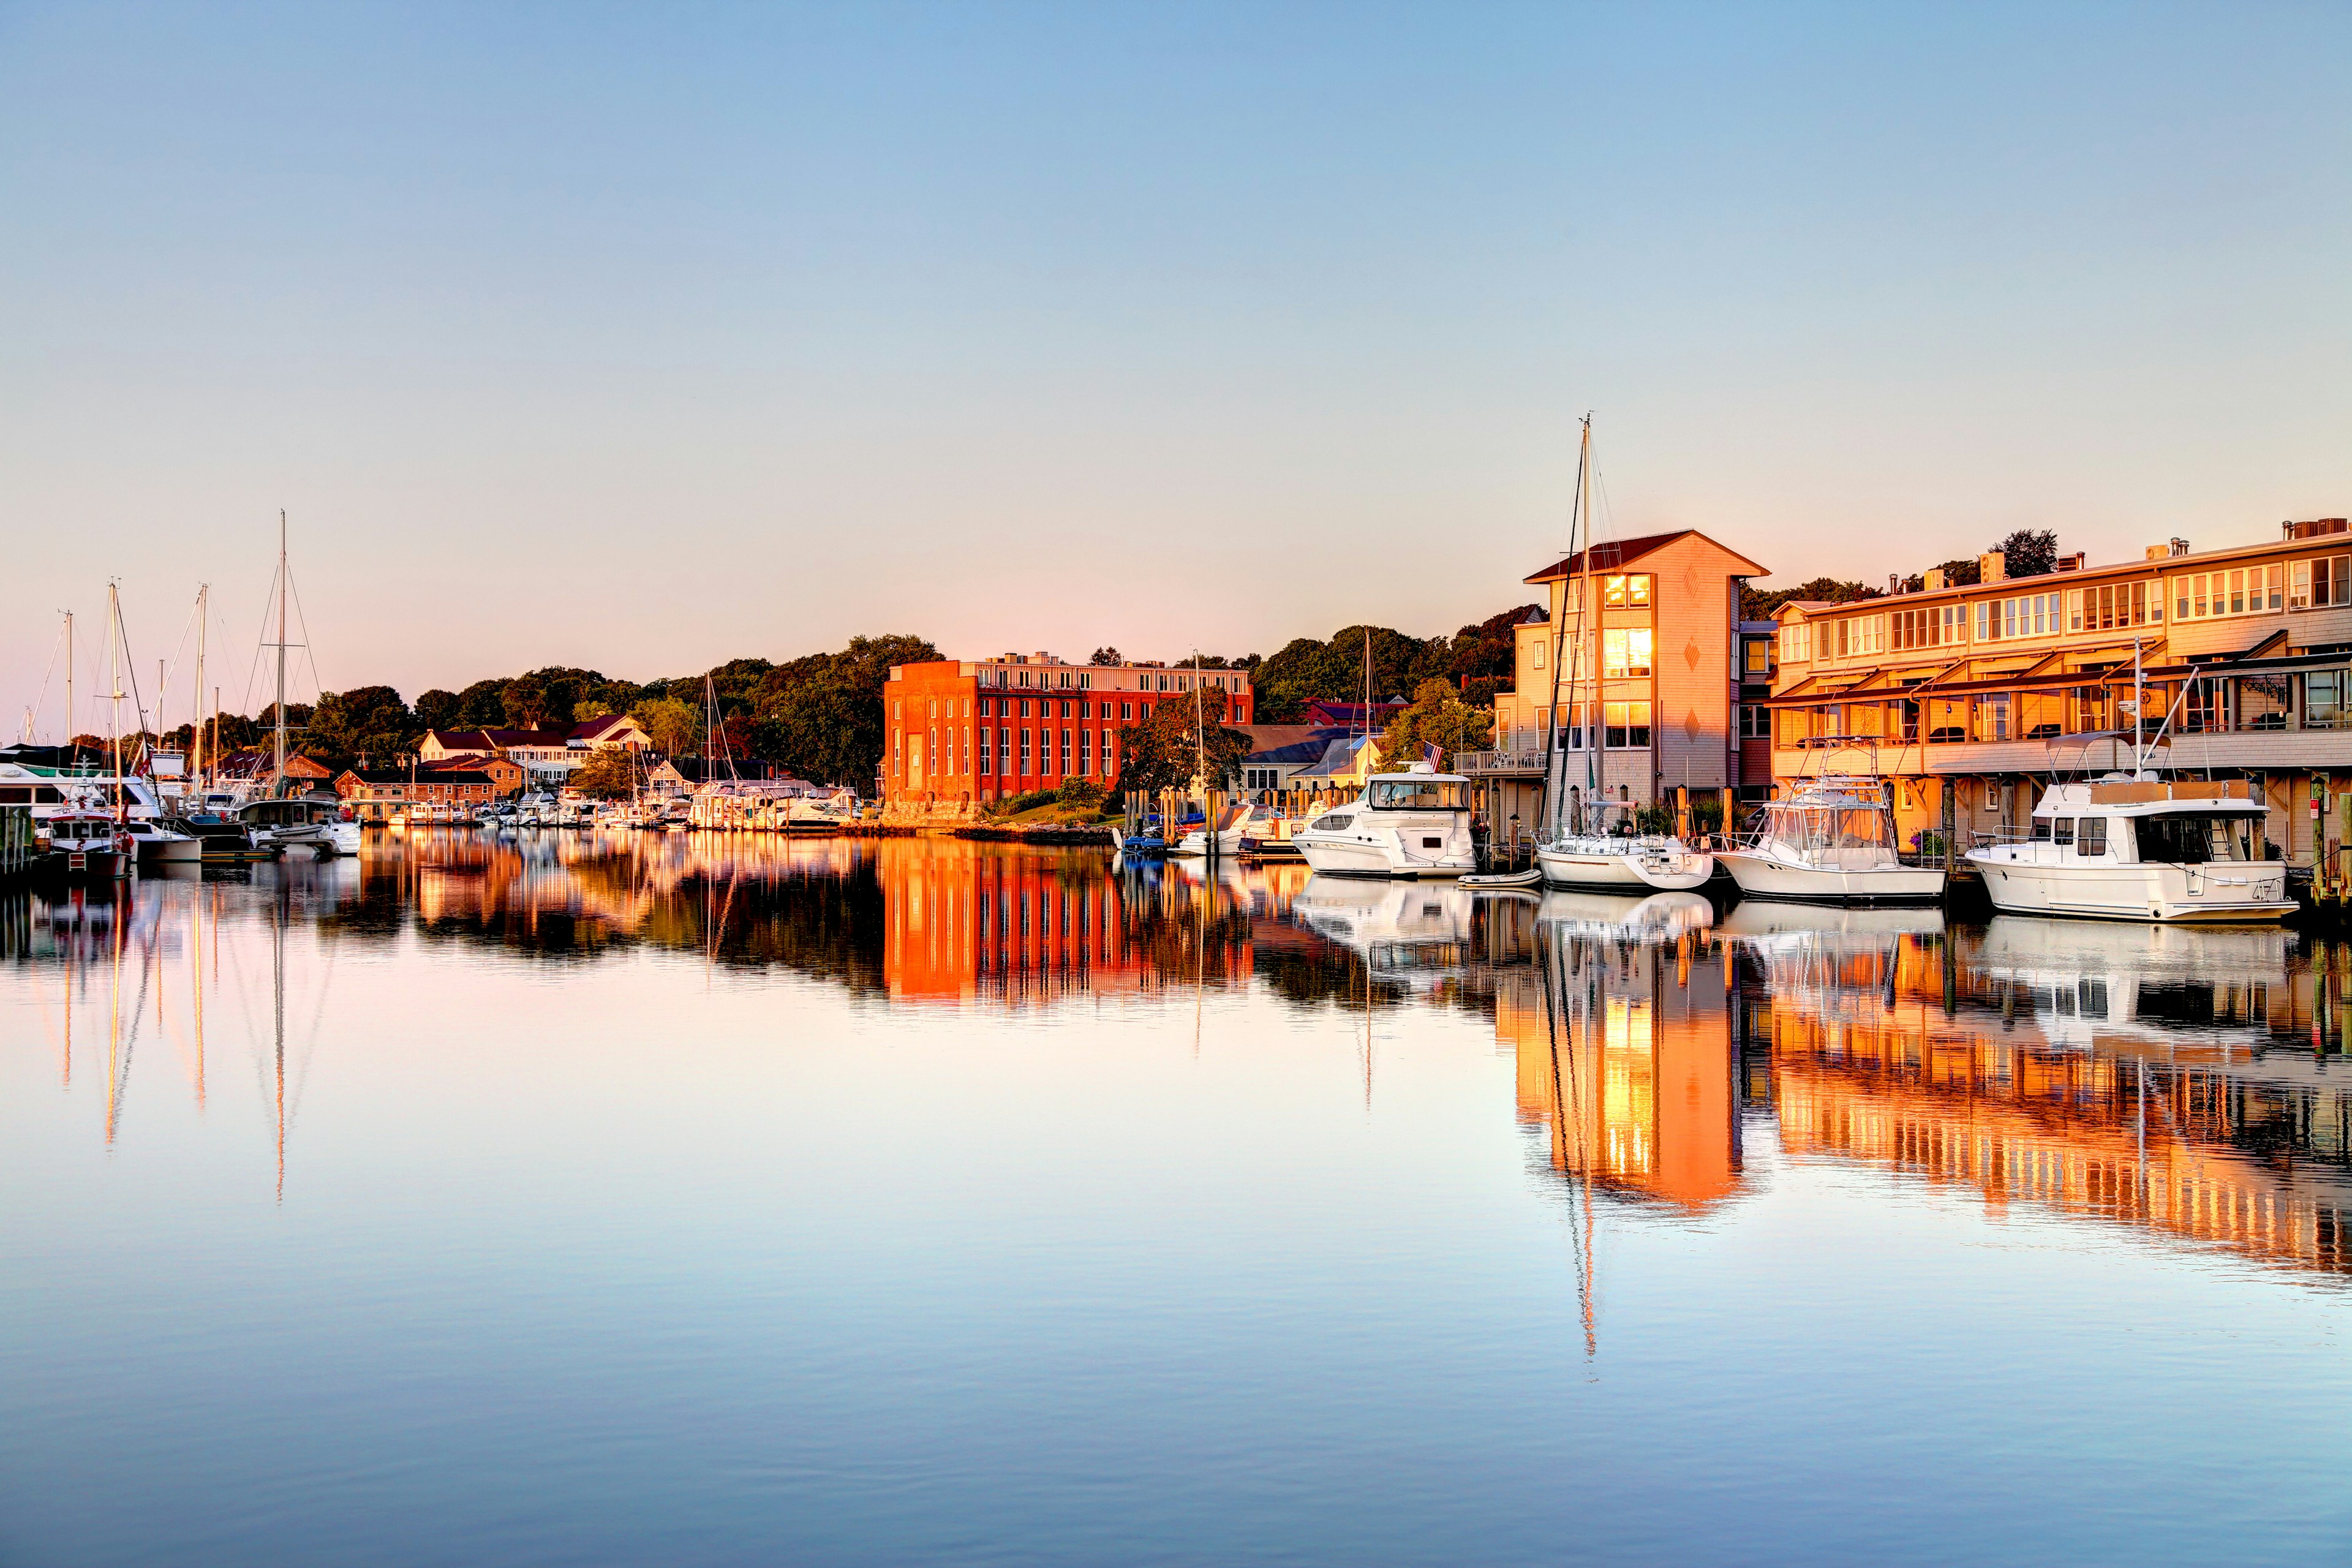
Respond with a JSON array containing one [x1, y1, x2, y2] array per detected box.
[[1714, 774, 1943, 905]]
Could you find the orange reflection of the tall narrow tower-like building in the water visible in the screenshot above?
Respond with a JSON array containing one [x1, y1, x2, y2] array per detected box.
[[1496, 924, 1741, 1208]]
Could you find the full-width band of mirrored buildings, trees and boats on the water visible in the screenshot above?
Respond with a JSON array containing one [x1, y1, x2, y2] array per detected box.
[[0, 832, 2352, 1274]]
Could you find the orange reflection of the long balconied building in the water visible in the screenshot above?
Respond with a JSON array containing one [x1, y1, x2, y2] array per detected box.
[[1747, 922, 2352, 1272]]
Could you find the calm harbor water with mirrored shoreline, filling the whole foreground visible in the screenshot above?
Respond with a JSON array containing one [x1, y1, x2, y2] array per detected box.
[[0, 835, 2352, 1566]]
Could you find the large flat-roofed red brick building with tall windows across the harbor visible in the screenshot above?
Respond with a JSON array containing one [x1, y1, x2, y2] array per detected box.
[[882, 654, 1254, 804]]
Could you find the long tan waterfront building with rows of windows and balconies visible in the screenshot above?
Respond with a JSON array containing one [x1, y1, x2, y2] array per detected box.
[[1769, 517, 2352, 865]]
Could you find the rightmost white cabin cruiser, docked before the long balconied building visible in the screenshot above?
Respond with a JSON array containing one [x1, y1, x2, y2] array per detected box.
[[1969, 774, 2296, 922]]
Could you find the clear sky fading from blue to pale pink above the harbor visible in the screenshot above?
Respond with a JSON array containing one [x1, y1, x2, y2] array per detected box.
[[0, 2, 2352, 733]]
